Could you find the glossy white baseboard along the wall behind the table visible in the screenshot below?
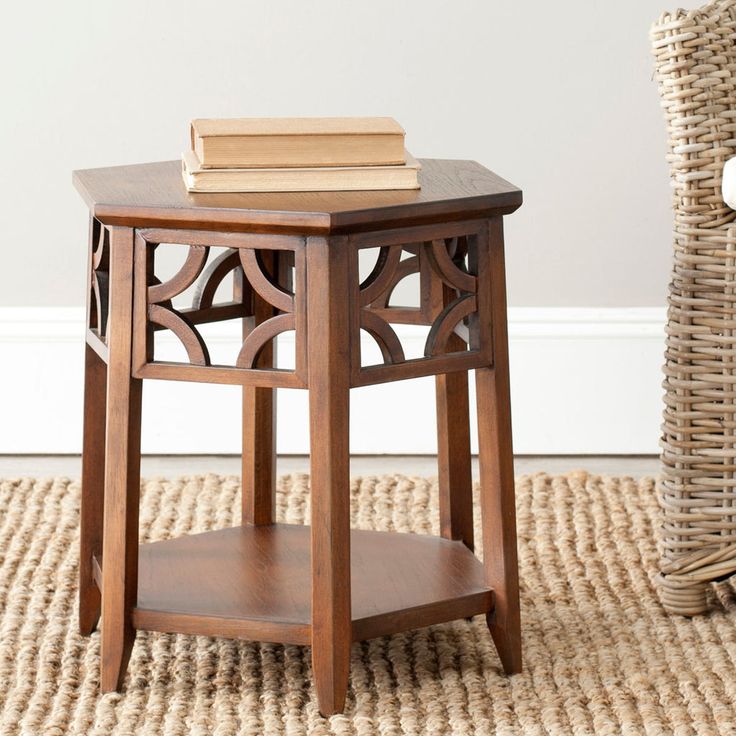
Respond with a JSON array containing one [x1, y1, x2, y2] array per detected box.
[[0, 307, 665, 454]]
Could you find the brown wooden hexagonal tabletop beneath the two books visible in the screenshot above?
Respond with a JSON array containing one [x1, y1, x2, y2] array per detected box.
[[74, 159, 522, 234]]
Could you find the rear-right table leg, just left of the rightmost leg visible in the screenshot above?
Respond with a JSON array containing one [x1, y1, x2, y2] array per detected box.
[[435, 338, 473, 549]]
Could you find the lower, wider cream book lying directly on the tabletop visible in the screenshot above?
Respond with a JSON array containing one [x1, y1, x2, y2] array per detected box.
[[182, 151, 420, 192]]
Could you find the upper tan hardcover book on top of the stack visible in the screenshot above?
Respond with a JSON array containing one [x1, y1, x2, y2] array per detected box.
[[191, 118, 404, 169]]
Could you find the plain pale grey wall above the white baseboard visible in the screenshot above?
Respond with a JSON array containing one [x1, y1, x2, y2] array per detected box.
[[0, 0, 688, 307]]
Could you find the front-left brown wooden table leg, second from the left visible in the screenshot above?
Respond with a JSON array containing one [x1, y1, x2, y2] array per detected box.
[[100, 227, 142, 692]]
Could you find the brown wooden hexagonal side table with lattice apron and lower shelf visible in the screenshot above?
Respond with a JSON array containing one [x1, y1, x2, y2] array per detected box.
[[74, 160, 521, 715]]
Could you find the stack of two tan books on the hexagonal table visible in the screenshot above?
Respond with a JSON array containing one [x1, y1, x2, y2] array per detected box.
[[182, 117, 419, 192]]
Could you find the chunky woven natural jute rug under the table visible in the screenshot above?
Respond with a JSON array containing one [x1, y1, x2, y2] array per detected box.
[[0, 472, 736, 736]]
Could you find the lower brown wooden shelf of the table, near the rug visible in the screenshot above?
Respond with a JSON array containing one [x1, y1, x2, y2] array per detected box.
[[95, 524, 493, 644]]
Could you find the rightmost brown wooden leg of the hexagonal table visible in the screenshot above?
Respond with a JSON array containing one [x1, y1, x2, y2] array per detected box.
[[475, 217, 521, 674]]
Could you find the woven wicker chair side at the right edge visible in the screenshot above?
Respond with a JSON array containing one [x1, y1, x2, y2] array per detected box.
[[651, 0, 736, 615]]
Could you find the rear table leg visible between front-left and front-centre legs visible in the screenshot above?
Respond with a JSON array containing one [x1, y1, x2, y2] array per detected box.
[[241, 262, 276, 525]]
